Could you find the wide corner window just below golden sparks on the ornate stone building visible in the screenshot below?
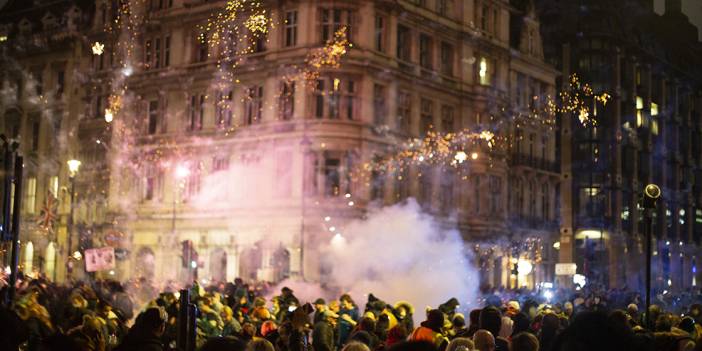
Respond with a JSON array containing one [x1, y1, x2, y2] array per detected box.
[[314, 78, 356, 120]]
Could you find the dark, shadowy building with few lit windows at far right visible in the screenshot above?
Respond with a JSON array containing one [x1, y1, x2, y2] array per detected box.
[[532, 0, 702, 290]]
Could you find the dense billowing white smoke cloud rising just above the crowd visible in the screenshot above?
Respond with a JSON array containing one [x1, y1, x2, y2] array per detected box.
[[327, 199, 479, 318]]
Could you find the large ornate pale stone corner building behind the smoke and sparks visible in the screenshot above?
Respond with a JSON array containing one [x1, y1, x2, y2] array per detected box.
[[0, 0, 560, 286]]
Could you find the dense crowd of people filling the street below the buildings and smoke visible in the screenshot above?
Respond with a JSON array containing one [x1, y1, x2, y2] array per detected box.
[[0, 278, 702, 351]]
